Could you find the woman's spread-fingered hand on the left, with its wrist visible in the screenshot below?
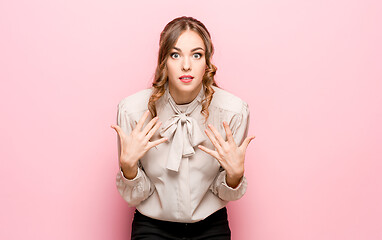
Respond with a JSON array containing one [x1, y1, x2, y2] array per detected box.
[[111, 111, 167, 179]]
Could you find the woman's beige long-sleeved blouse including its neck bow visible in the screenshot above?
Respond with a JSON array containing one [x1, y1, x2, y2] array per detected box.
[[116, 84, 249, 223]]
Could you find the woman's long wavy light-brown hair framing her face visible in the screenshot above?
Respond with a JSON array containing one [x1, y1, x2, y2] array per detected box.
[[148, 16, 218, 121]]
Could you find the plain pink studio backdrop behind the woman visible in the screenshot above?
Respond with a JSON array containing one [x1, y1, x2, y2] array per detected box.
[[0, 0, 382, 240]]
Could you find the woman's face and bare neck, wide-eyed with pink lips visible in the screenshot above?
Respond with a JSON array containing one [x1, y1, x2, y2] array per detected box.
[[166, 30, 207, 104]]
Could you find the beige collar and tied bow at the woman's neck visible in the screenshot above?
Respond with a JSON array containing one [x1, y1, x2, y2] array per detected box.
[[160, 86, 206, 172]]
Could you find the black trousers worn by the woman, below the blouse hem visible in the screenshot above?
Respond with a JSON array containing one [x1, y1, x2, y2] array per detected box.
[[131, 207, 231, 240]]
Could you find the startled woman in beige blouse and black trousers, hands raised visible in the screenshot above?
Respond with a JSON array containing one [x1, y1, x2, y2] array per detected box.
[[112, 17, 254, 239]]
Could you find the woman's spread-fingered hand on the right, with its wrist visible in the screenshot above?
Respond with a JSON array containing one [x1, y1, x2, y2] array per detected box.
[[198, 122, 255, 188]]
